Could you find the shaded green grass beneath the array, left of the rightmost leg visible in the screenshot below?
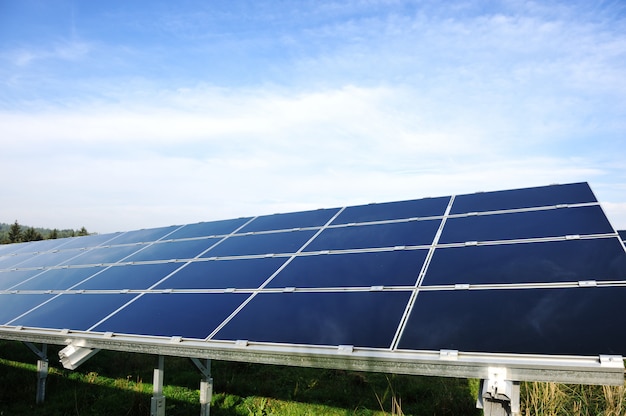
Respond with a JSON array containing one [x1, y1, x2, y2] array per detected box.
[[0, 340, 480, 416]]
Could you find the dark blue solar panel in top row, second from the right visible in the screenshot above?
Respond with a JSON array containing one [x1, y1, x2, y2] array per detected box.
[[332, 196, 450, 225]]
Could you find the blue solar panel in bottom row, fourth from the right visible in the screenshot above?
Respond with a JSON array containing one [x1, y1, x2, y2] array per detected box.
[[11, 293, 136, 331]]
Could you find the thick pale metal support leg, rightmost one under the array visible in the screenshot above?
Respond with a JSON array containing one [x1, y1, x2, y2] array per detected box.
[[476, 368, 520, 416]]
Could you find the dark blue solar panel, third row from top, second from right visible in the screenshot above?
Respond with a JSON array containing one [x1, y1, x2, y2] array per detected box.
[[267, 250, 428, 288]]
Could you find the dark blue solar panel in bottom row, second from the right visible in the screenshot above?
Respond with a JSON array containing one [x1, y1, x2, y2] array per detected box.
[[214, 292, 410, 348]]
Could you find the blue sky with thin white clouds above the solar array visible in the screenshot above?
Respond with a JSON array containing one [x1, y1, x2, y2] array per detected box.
[[0, 0, 626, 233]]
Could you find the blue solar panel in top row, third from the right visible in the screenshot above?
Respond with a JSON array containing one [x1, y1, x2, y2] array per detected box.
[[241, 208, 339, 233]]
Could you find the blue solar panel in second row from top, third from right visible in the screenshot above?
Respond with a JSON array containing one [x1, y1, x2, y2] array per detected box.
[[202, 230, 316, 257]]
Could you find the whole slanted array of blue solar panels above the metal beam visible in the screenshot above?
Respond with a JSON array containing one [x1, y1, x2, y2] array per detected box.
[[0, 183, 626, 356]]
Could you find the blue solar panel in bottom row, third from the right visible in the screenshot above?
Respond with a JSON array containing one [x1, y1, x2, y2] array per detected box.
[[94, 293, 250, 339]]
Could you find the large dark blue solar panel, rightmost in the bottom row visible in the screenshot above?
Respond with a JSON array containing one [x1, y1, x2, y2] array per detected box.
[[399, 287, 626, 356]]
